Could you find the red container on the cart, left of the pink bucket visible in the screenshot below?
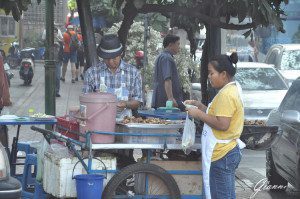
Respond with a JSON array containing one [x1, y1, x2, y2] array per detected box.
[[56, 116, 79, 140]]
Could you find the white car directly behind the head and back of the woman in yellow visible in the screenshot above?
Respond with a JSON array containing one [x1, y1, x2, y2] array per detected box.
[[235, 62, 288, 121]]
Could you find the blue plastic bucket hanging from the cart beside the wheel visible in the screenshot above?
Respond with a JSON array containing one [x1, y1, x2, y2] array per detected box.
[[74, 174, 104, 199]]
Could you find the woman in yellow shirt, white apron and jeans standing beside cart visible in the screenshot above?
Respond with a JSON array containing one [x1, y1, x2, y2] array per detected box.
[[185, 53, 245, 199]]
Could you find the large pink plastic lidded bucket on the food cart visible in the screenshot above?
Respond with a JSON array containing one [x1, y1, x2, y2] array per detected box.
[[79, 93, 117, 143]]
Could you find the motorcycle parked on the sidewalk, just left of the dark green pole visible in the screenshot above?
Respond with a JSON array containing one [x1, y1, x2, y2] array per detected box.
[[19, 58, 34, 86]]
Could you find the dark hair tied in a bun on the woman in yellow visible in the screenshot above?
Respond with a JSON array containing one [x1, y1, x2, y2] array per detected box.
[[209, 52, 238, 77]]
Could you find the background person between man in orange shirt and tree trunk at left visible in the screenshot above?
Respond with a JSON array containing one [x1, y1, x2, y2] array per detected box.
[[75, 27, 85, 81]]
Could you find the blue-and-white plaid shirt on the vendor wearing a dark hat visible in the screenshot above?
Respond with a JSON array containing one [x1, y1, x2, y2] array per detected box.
[[82, 61, 143, 102]]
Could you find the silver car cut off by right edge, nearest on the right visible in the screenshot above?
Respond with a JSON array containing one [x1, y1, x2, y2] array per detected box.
[[266, 79, 300, 191]]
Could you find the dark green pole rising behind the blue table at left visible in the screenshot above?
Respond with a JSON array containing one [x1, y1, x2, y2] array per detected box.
[[45, 0, 56, 121]]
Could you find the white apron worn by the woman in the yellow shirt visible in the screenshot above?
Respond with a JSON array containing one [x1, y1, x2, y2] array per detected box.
[[201, 82, 246, 199]]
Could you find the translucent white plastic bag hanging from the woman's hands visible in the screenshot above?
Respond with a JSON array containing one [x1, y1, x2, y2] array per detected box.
[[181, 114, 196, 153]]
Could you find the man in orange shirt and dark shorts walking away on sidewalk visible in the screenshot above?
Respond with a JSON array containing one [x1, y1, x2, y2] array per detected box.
[[60, 25, 77, 83]]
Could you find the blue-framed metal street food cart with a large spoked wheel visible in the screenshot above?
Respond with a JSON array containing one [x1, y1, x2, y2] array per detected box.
[[32, 109, 203, 198]]
